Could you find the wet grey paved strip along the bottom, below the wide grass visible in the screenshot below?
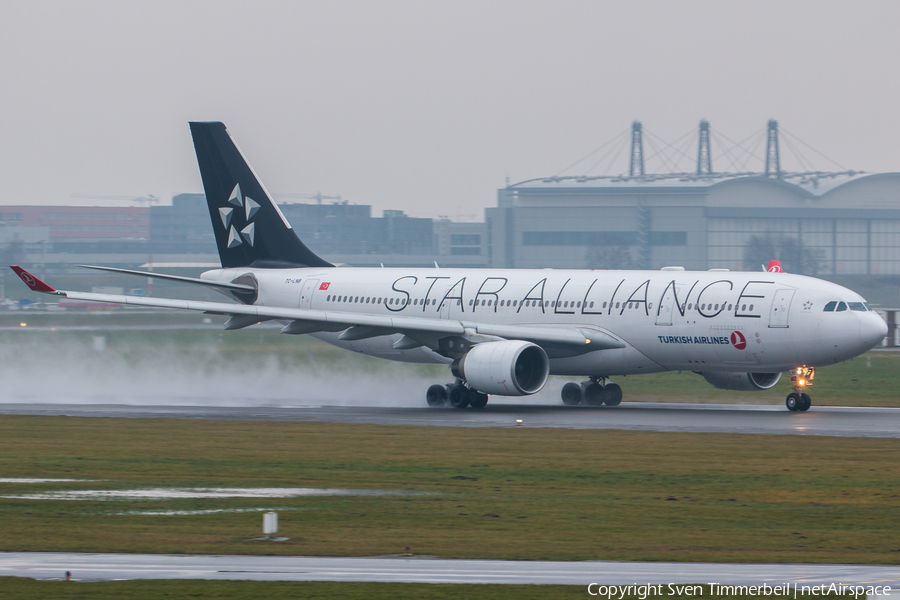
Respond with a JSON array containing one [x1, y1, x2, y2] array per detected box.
[[0, 552, 900, 589]]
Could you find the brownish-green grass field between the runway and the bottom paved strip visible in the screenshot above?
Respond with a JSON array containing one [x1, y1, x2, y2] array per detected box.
[[0, 416, 900, 564]]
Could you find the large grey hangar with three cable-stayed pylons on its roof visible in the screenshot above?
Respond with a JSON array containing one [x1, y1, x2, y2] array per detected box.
[[486, 121, 900, 276]]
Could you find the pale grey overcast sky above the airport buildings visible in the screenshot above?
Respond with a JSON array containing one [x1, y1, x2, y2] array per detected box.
[[0, 0, 900, 219]]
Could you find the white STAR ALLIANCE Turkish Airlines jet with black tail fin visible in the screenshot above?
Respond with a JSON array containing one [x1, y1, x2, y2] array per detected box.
[[12, 122, 887, 411]]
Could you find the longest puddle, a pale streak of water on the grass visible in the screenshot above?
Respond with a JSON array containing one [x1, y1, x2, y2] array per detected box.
[[0, 488, 425, 500]]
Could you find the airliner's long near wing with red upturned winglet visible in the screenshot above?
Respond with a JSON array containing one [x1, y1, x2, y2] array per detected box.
[[10, 265, 625, 352]]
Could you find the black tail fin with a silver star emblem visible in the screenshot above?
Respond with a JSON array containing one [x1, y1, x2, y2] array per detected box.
[[190, 121, 333, 268]]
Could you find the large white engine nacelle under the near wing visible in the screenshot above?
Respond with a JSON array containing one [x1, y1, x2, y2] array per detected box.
[[450, 340, 550, 396]]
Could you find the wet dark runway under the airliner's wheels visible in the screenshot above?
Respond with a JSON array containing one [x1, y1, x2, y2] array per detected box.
[[0, 399, 900, 438]]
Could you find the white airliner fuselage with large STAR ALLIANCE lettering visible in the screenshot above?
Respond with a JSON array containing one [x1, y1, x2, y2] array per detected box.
[[203, 268, 886, 376]]
